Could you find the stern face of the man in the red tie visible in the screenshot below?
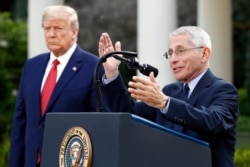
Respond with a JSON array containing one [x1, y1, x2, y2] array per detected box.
[[43, 19, 78, 56]]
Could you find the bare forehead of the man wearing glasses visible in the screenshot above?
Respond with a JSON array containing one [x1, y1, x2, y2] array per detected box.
[[168, 34, 192, 49]]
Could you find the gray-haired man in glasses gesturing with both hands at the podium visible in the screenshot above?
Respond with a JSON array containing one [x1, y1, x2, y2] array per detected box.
[[99, 26, 239, 167]]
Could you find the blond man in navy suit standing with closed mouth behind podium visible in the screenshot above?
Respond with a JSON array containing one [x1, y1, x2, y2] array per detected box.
[[9, 6, 107, 167]]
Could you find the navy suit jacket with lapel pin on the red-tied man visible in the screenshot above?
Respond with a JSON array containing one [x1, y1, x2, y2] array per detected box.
[[9, 47, 103, 167]]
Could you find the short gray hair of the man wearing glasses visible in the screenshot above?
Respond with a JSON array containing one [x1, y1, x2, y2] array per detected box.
[[169, 26, 212, 50]]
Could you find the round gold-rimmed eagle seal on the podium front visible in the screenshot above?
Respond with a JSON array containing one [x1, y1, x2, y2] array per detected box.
[[59, 127, 92, 167]]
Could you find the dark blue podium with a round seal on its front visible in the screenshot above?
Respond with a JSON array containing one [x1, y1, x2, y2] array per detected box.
[[41, 112, 212, 167]]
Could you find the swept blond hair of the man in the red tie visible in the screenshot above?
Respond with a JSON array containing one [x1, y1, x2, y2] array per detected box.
[[42, 5, 79, 30]]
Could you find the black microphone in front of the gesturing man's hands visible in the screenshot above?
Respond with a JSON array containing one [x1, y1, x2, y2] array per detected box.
[[113, 55, 158, 77]]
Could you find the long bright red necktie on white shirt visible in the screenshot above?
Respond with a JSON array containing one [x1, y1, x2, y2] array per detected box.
[[41, 59, 60, 116]]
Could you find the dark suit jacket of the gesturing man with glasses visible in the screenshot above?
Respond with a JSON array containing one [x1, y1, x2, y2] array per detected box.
[[102, 70, 238, 167]]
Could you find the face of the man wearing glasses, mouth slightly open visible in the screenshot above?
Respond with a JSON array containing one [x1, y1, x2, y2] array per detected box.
[[168, 35, 208, 82]]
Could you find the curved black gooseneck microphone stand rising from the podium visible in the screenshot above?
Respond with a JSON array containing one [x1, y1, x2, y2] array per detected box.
[[94, 51, 137, 112]]
